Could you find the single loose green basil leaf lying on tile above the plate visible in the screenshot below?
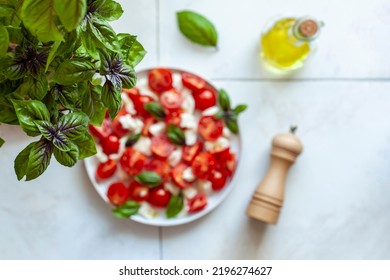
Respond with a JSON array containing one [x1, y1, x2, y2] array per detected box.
[[177, 11, 218, 47]]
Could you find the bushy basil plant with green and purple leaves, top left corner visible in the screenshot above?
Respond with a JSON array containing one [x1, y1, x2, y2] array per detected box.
[[0, 0, 146, 181]]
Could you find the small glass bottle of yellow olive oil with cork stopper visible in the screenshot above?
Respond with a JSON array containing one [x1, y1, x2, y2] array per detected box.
[[261, 18, 320, 73]]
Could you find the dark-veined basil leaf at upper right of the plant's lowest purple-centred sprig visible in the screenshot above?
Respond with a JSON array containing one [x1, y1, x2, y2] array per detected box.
[[57, 112, 89, 140]]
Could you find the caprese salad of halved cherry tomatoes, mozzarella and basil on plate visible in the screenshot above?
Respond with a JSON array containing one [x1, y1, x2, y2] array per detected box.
[[90, 68, 246, 218]]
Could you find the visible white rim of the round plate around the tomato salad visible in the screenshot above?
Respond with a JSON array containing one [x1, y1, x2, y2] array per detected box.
[[84, 69, 241, 226]]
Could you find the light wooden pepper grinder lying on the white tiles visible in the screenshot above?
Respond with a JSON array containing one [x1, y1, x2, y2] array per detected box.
[[247, 127, 303, 224]]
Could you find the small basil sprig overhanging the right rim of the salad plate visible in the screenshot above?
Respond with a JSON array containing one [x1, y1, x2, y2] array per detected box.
[[214, 89, 248, 134]]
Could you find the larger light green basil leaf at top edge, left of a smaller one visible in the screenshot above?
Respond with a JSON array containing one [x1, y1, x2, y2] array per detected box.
[[22, 0, 64, 42]]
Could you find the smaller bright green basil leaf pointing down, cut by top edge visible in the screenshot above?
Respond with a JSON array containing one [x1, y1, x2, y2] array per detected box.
[[54, 0, 87, 31]]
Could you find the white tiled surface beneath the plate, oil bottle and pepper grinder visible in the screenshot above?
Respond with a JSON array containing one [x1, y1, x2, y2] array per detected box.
[[0, 0, 390, 259]]
